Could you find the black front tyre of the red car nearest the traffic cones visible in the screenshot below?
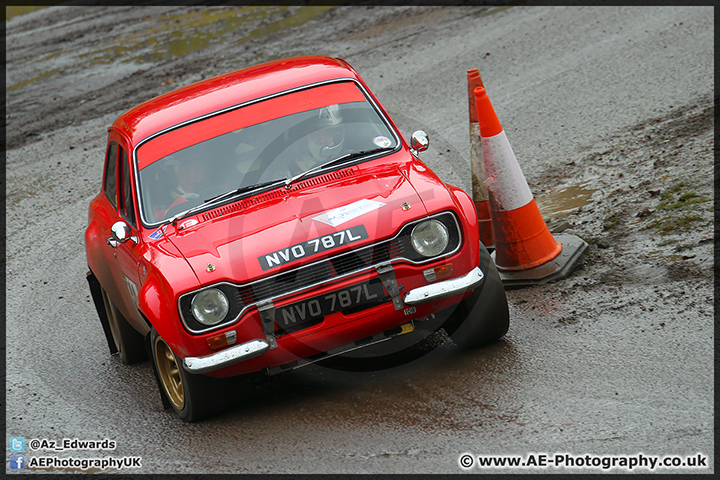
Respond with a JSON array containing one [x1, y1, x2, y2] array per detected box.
[[443, 244, 510, 348]]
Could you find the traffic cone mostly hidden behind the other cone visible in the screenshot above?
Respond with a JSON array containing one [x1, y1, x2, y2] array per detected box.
[[467, 68, 495, 249]]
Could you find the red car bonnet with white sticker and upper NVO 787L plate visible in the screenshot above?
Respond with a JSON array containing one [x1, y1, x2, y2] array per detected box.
[[156, 157, 434, 285]]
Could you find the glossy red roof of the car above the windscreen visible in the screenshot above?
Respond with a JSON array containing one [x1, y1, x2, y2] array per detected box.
[[110, 55, 362, 147]]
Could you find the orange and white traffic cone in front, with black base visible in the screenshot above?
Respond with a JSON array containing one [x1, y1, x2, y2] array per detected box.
[[473, 87, 587, 286]]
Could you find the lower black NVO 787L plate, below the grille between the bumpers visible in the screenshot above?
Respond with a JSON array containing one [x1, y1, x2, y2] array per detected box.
[[275, 280, 385, 331]]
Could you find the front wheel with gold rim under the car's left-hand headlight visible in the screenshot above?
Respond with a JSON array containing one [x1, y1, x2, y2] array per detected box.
[[150, 328, 218, 422]]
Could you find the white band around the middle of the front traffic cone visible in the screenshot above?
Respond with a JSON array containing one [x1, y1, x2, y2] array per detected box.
[[482, 130, 533, 212]]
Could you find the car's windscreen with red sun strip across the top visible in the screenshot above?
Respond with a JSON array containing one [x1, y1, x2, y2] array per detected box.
[[137, 82, 397, 224]]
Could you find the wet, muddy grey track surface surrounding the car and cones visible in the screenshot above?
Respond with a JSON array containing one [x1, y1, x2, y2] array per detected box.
[[6, 7, 715, 473]]
